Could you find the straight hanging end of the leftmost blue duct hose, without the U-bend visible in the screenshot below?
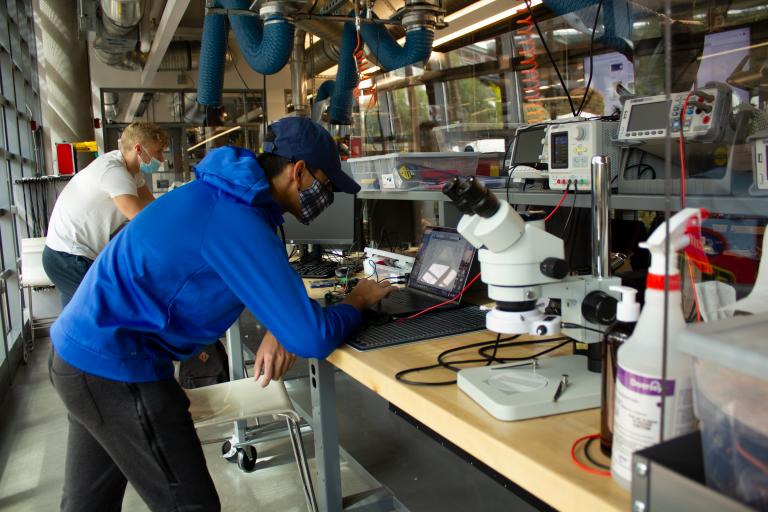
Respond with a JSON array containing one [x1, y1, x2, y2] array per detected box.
[[197, 14, 228, 106]]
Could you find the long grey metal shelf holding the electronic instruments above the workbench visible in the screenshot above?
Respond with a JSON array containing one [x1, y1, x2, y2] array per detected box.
[[357, 189, 768, 217]]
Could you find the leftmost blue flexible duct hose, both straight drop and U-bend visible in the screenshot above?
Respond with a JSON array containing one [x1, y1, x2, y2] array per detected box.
[[198, 0, 294, 106]]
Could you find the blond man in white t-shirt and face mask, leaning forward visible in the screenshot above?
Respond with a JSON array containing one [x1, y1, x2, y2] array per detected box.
[[43, 122, 168, 307]]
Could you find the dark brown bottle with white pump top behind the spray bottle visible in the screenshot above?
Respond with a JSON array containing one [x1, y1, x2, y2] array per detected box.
[[600, 286, 640, 456]]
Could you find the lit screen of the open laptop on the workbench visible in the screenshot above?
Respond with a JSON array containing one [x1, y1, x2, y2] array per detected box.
[[408, 226, 475, 299]]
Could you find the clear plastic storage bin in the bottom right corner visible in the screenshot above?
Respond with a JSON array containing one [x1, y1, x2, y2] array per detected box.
[[680, 314, 768, 510]]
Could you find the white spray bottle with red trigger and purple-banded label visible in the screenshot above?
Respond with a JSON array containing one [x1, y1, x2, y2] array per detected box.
[[611, 208, 711, 489]]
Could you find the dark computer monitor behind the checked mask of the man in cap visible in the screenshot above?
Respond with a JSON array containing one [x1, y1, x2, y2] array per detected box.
[[283, 162, 355, 246]]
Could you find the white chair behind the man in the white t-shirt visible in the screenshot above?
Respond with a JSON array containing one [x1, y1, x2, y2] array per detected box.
[[19, 236, 56, 363]]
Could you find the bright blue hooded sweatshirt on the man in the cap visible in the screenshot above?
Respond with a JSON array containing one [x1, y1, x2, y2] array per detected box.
[[51, 147, 361, 382]]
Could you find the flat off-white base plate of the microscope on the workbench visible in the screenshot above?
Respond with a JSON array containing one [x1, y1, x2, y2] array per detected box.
[[458, 355, 600, 421]]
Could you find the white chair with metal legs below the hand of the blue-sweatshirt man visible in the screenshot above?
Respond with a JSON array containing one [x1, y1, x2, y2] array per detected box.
[[184, 378, 317, 512]]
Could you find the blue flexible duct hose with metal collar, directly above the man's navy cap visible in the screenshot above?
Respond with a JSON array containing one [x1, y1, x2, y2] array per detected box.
[[328, 0, 440, 124]]
